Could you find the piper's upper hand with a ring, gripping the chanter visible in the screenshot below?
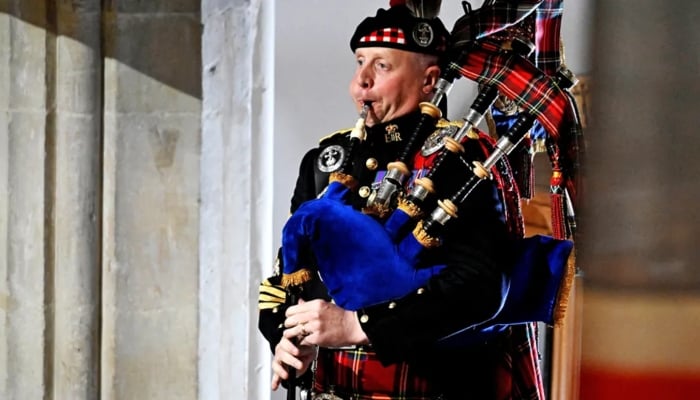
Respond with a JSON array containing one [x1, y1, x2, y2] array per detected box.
[[284, 300, 369, 347]]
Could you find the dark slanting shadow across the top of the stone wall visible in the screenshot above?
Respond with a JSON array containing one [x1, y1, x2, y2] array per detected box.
[[0, 0, 203, 99]]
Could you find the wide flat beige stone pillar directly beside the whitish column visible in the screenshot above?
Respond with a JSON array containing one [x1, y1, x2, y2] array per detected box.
[[101, 0, 201, 400]]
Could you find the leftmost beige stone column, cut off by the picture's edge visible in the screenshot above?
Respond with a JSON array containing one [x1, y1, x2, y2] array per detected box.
[[0, 2, 52, 400]]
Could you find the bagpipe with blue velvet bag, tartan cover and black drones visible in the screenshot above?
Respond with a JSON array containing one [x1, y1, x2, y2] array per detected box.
[[281, 1, 576, 345]]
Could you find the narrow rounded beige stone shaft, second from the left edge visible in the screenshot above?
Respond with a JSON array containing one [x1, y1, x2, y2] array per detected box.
[[51, 0, 102, 399]]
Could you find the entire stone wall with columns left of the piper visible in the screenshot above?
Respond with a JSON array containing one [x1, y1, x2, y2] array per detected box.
[[0, 0, 272, 400]]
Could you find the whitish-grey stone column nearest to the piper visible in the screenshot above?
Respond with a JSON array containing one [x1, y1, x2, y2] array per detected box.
[[199, 0, 274, 400]]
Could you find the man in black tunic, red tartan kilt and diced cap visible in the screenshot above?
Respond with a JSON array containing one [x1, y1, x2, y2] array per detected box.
[[259, 6, 539, 399]]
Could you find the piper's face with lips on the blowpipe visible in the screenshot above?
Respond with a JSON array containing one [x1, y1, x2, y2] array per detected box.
[[350, 47, 439, 126]]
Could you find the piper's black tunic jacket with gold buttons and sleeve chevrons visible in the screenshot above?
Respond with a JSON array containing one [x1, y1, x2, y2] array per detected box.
[[259, 109, 510, 364]]
